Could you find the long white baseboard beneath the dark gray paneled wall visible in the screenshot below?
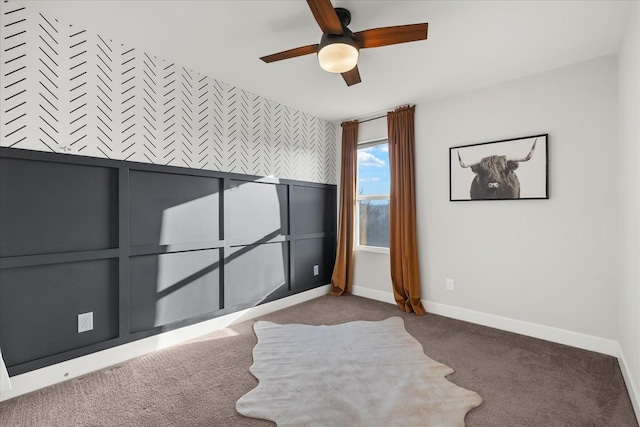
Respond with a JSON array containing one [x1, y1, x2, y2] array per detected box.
[[0, 285, 330, 401]]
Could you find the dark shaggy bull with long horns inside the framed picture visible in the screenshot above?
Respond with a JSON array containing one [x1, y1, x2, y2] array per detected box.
[[458, 139, 538, 200]]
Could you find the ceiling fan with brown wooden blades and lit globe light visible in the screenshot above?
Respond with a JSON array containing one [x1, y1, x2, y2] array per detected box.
[[260, 0, 429, 86]]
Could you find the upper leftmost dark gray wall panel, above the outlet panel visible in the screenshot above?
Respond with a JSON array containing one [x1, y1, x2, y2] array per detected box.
[[0, 158, 118, 257]]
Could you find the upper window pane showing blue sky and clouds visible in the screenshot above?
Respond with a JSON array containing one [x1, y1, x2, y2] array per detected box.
[[358, 142, 390, 195]]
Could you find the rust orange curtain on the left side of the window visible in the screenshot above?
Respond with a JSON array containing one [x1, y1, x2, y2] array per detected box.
[[329, 120, 358, 296]]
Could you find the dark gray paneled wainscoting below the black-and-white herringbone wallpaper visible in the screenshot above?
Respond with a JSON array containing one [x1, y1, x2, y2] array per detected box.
[[0, 147, 336, 375]]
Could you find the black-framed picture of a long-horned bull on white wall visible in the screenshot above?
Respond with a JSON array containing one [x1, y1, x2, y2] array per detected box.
[[449, 134, 549, 202]]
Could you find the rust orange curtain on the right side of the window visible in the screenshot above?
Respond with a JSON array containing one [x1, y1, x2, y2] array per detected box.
[[387, 106, 425, 316]]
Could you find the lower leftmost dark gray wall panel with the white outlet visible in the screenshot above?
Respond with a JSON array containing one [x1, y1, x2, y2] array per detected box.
[[0, 259, 118, 366]]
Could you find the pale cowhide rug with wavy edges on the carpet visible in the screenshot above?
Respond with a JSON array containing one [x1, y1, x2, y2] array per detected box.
[[236, 317, 482, 427]]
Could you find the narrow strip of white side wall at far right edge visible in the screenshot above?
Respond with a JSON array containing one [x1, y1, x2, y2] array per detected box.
[[617, 3, 640, 415]]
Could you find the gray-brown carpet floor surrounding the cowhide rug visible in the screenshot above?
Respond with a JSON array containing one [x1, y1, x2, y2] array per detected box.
[[0, 296, 638, 427]]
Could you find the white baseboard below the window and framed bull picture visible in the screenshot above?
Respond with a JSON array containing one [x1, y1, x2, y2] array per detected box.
[[353, 286, 619, 356]]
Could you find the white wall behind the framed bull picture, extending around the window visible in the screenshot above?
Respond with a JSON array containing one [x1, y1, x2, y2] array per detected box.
[[354, 56, 617, 350]]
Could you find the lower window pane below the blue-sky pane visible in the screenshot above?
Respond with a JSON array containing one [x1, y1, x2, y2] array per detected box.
[[358, 200, 389, 248]]
